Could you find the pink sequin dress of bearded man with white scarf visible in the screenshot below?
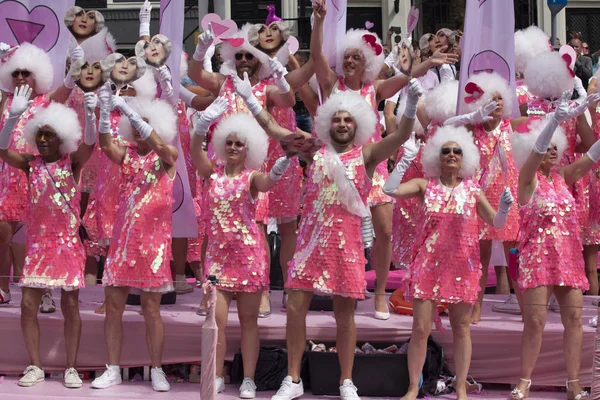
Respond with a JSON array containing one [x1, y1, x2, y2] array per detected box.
[[285, 146, 371, 299]]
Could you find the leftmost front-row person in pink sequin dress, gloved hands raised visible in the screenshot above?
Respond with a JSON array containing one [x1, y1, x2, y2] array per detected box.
[[0, 85, 96, 388]]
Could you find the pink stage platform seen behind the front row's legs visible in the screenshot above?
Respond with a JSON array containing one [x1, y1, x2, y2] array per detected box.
[[0, 287, 597, 390]]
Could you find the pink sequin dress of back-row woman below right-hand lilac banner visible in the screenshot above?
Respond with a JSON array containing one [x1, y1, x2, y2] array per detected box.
[[473, 119, 519, 242]]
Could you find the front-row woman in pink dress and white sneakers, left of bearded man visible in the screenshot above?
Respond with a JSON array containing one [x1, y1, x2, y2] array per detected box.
[[192, 97, 290, 399]]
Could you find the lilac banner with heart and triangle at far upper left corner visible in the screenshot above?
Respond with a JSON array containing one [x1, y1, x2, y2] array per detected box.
[[0, 0, 75, 89]]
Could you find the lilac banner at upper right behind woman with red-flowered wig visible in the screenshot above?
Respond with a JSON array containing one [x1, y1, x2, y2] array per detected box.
[[457, 0, 520, 116]]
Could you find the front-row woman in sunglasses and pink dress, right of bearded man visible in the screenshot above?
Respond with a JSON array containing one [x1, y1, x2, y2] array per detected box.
[[384, 126, 513, 400]]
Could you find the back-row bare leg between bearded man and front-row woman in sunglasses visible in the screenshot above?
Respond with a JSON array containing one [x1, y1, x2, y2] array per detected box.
[[371, 203, 394, 313]]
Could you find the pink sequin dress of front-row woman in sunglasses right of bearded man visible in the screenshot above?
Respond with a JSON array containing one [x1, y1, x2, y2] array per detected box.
[[404, 178, 481, 304]]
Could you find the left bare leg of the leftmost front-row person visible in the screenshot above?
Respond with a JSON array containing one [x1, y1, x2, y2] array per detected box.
[[21, 287, 44, 368]]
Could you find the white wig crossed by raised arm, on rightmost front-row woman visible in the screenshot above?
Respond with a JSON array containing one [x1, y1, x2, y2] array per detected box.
[[510, 118, 567, 169]]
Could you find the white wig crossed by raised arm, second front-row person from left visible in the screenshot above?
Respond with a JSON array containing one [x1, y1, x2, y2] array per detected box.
[[119, 97, 177, 143]]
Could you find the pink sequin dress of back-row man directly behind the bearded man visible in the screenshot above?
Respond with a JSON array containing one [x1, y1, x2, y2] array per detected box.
[[333, 76, 393, 207]]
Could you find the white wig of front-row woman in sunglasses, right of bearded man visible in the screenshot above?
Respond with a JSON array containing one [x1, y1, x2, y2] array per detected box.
[[421, 126, 479, 178]]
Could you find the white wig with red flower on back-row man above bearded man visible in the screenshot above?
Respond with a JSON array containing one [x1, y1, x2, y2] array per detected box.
[[337, 29, 385, 82]]
